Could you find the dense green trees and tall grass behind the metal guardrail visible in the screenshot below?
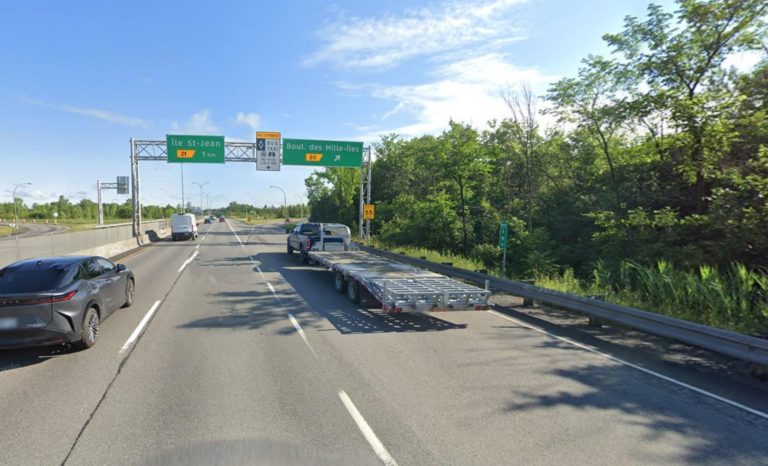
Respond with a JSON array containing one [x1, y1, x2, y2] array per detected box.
[[306, 0, 768, 334]]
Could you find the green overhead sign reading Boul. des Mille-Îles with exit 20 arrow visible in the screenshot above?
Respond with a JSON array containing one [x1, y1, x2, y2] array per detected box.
[[283, 138, 363, 168]]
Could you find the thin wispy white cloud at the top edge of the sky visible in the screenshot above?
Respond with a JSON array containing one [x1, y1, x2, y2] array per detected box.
[[303, 0, 525, 69]]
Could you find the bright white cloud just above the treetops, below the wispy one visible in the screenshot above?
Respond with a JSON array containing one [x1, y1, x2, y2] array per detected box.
[[358, 53, 557, 141]]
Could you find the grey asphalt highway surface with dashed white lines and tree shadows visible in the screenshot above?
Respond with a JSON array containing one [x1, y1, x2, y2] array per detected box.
[[0, 222, 768, 465]]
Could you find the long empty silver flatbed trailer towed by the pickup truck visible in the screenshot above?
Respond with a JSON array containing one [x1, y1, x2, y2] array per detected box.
[[309, 250, 491, 313]]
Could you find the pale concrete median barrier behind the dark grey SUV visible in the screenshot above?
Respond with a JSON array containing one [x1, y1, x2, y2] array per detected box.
[[0, 220, 170, 267]]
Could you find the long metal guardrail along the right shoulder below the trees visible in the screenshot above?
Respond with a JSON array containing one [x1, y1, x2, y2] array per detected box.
[[360, 246, 768, 366]]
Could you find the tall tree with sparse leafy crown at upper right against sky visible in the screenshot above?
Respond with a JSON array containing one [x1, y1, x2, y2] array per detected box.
[[604, 0, 768, 213]]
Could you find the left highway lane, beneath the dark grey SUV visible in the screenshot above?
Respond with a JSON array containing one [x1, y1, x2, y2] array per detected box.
[[0, 224, 208, 464]]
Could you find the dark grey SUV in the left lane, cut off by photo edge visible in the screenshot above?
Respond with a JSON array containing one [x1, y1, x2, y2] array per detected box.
[[0, 256, 136, 349]]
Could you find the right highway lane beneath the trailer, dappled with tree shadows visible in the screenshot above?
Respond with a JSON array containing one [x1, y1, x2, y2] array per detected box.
[[246, 222, 768, 464]]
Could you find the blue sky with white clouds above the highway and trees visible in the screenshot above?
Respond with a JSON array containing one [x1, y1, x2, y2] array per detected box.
[[0, 0, 684, 206]]
